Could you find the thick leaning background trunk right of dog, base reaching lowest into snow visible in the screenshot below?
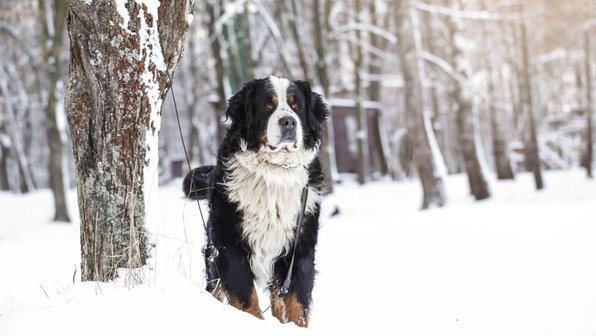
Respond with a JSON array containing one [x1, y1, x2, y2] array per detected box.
[[394, 0, 446, 209]]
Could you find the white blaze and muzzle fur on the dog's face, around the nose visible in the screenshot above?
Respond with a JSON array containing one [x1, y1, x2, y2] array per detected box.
[[267, 76, 303, 151]]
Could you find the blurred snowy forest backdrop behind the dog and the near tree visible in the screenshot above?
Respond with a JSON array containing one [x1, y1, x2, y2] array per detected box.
[[0, 0, 596, 213]]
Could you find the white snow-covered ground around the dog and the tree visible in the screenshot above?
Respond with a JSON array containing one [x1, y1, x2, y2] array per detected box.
[[0, 171, 596, 336]]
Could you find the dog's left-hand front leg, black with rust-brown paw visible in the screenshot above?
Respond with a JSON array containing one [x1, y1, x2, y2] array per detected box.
[[205, 245, 263, 319]]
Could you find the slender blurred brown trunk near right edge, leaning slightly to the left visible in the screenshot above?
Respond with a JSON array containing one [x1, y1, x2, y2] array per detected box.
[[519, 0, 544, 190]]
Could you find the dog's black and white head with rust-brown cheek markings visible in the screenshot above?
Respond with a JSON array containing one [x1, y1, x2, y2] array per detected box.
[[226, 76, 328, 153]]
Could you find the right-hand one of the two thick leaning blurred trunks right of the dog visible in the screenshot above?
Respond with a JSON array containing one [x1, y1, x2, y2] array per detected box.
[[446, 0, 490, 200]]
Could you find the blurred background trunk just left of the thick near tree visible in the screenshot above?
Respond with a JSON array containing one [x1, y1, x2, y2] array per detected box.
[[38, 0, 70, 222]]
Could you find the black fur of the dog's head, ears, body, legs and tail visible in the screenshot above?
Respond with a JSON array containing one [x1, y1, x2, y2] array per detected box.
[[183, 78, 328, 326]]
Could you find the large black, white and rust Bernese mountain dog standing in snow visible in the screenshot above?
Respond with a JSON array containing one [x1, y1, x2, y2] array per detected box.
[[183, 76, 328, 327]]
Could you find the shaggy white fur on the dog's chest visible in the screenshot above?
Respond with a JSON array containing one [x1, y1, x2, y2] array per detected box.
[[224, 143, 320, 287]]
